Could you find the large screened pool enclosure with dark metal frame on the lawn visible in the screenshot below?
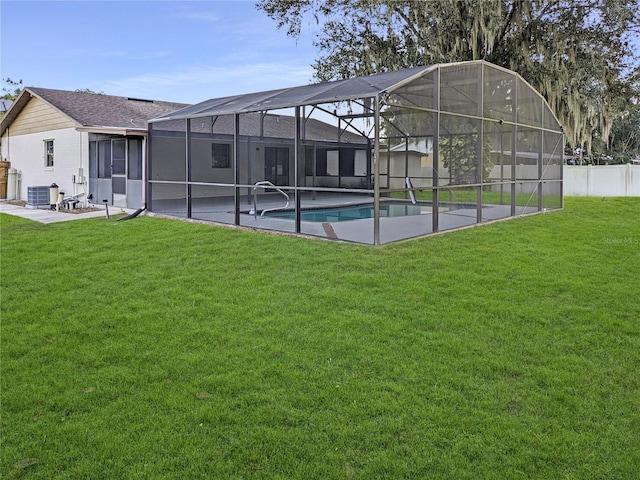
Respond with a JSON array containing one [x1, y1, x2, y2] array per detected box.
[[146, 61, 564, 245]]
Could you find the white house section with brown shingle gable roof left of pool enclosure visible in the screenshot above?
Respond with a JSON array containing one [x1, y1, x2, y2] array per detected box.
[[0, 87, 186, 208]]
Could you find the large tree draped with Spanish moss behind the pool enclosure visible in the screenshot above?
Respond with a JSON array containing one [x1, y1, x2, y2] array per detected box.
[[257, 0, 640, 154]]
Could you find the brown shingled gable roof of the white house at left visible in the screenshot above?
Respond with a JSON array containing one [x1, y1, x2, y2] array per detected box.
[[0, 87, 188, 135]]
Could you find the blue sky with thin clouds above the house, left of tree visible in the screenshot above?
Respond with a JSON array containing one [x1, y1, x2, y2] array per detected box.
[[0, 0, 317, 103]]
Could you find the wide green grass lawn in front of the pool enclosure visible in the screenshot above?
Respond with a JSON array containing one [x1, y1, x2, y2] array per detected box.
[[0, 198, 640, 479]]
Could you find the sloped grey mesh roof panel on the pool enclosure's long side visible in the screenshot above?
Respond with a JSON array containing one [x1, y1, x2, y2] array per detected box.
[[149, 66, 431, 122]]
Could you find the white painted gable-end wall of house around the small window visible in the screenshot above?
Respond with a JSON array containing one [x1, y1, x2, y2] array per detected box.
[[2, 124, 88, 200]]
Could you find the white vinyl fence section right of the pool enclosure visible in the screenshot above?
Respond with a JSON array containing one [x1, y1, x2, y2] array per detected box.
[[563, 164, 640, 197]]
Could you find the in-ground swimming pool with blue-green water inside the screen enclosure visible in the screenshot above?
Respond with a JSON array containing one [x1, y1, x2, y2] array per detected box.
[[265, 203, 431, 222]]
